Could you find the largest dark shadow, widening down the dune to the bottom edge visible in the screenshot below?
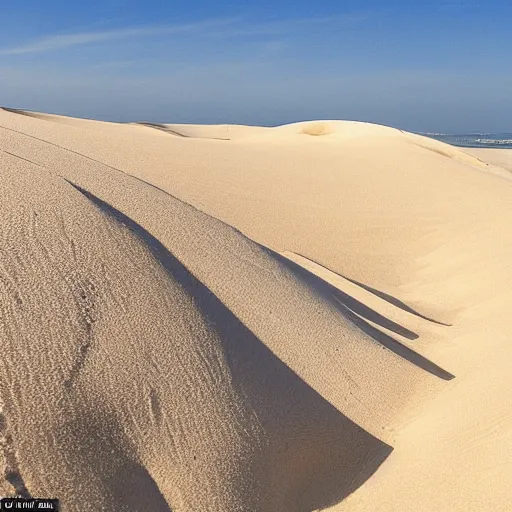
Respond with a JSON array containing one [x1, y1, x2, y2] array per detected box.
[[66, 180, 392, 512]]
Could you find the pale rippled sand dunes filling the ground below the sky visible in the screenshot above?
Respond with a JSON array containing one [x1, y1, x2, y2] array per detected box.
[[0, 106, 512, 512]]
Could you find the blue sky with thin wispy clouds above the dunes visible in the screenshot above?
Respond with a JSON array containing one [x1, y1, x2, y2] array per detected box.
[[0, 0, 512, 133]]
